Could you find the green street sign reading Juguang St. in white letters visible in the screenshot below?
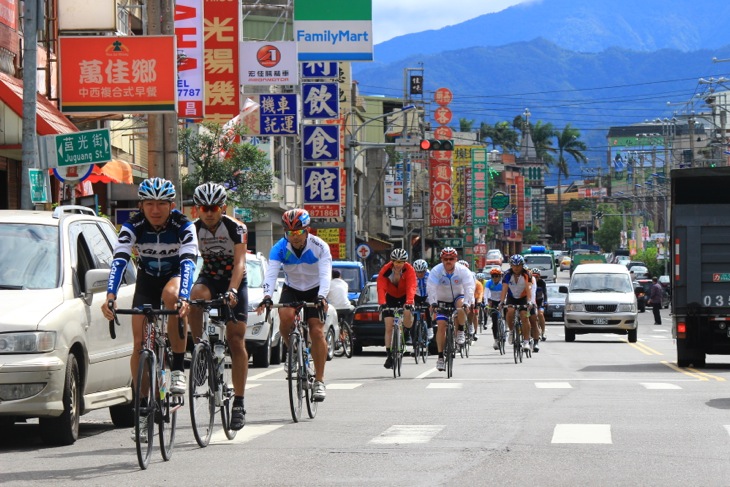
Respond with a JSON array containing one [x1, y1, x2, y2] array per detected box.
[[40, 129, 112, 168]]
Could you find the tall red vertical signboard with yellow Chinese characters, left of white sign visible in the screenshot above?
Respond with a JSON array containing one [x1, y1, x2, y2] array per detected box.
[[203, 0, 241, 124]]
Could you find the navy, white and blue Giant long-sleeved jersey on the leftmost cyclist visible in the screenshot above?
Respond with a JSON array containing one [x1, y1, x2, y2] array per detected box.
[[107, 210, 198, 299]]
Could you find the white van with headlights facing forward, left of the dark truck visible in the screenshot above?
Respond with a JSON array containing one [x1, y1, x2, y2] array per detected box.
[[560, 264, 639, 343]]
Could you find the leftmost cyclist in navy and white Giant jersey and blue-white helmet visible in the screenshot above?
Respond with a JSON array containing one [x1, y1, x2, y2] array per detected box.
[[101, 178, 198, 438]]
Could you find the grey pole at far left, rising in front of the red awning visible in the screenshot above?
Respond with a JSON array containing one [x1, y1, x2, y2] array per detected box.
[[20, 0, 43, 210]]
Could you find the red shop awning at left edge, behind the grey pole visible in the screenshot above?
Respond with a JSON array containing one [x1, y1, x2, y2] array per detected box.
[[0, 72, 79, 159]]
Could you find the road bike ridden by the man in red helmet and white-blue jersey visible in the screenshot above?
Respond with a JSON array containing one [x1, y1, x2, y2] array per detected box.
[[266, 301, 325, 423]]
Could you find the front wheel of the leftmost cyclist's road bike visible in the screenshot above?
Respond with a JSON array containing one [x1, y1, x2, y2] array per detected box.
[[134, 350, 157, 470]]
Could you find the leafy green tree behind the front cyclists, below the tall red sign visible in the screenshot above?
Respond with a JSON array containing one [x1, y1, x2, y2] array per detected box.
[[179, 123, 274, 217]]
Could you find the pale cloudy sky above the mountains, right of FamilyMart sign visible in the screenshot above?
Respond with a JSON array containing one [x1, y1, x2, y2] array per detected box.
[[373, 0, 526, 44]]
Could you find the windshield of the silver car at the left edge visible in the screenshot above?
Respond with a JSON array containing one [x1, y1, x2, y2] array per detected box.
[[0, 223, 60, 289]]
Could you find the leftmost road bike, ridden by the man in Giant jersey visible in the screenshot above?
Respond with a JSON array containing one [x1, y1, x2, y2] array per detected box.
[[107, 301, 185, 470]]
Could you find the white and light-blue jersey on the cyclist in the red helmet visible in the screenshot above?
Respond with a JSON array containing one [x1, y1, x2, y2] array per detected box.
[[264, 234, 332, 296]]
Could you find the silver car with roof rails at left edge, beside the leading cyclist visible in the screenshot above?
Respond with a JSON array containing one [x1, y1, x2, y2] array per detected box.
[[0, 206, 136, 445]]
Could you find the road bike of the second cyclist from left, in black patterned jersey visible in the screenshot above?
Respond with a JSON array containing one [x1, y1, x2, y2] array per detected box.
[[188, 295, 237, 448]]
